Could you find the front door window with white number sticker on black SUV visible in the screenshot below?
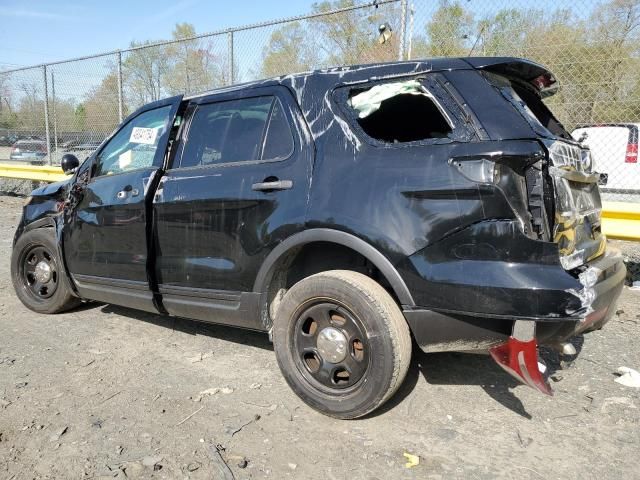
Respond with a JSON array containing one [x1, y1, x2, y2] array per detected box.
[[93, 105, 171, 177]]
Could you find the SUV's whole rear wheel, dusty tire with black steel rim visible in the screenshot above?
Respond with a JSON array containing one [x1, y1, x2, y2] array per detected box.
[[273, 270, 411, 419]]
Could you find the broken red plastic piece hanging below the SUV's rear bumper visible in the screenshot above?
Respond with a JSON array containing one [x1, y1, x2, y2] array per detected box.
[[489, 337, 553, 395]]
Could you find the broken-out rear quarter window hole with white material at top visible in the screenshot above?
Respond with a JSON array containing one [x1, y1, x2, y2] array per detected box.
[[347, 80, 453, 143]]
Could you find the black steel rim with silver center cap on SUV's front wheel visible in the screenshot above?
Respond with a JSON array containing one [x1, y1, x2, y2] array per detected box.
[[20, 245, 58, 300]]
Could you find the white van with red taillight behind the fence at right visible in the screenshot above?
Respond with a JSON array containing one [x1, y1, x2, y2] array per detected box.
[[571, 123, 640, 193]]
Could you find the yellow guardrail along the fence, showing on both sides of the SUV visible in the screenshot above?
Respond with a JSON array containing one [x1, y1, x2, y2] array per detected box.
[[0, 163, 640, 241]]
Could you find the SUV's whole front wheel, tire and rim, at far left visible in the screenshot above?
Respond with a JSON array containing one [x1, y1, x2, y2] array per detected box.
[[11, 228, 80, 313]]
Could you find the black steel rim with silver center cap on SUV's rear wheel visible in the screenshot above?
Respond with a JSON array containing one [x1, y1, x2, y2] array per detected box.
[[293, 301, 370, 391]]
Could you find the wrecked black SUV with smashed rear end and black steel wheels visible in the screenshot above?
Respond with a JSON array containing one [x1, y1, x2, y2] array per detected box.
[[12, 58, 625, 418]]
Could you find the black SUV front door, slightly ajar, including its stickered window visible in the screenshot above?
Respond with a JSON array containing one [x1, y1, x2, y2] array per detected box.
[[63, 97, 182, 311]]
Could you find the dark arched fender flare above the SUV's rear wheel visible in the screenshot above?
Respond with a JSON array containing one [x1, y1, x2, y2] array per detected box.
[[253, 228, 415, 307]]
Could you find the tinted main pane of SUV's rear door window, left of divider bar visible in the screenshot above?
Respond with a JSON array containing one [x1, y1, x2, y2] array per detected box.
[[180, 97, 273, 168]]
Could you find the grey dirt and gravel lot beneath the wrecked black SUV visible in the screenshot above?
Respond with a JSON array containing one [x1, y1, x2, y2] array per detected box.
[[0, 193, 640, 480]]
